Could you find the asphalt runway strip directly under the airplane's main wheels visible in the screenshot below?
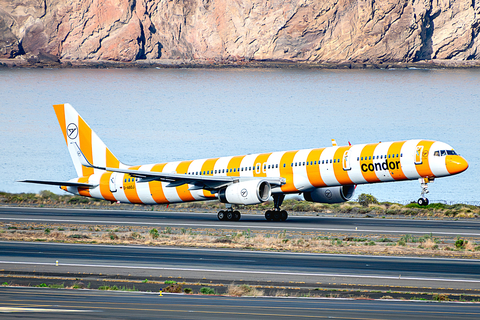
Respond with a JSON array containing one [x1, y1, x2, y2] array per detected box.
[[0, 206, 480, 237]]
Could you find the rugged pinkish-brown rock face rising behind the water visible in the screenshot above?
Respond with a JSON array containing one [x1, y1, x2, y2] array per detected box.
[[0, 0, 480, 63]]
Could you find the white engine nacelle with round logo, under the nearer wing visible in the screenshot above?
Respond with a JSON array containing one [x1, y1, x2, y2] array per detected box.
[[218, 180, 272, 204]]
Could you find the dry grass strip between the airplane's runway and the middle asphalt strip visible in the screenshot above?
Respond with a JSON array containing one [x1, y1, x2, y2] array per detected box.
[[0, 222, 480, 258]]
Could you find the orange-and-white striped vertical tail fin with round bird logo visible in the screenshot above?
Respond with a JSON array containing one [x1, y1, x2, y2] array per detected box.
[[53, 103, 124, 177]]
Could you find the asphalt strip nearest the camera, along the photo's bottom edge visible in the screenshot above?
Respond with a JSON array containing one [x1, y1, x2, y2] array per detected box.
[[0, 288, 480, 320]]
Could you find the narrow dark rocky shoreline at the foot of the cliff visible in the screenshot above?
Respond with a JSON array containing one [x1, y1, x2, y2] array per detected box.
[[0, 58, 480, 70]]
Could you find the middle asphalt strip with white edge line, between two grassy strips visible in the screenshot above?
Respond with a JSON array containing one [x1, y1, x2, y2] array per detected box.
[[0, 242, 480, 289]]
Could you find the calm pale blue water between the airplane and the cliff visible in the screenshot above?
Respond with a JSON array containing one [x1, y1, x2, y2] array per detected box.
[[0, 69, 480, 202]]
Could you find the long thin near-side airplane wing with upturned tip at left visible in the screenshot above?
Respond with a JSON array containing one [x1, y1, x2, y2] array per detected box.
[[75, 143, 286, 190]]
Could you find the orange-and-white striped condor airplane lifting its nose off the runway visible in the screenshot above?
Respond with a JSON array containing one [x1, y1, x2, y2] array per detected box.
[[20, 103, 468, 221]]
